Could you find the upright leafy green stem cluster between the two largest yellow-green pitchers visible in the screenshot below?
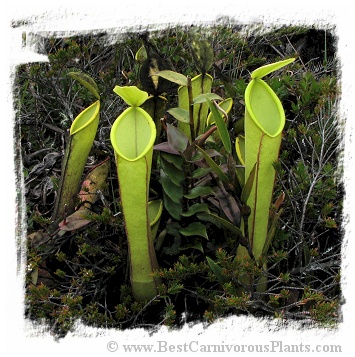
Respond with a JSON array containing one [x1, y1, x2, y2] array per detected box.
[[154, 96, 245, 254]]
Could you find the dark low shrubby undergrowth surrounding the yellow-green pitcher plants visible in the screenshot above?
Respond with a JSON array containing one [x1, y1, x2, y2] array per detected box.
[[14, 26, 343, 336]]
